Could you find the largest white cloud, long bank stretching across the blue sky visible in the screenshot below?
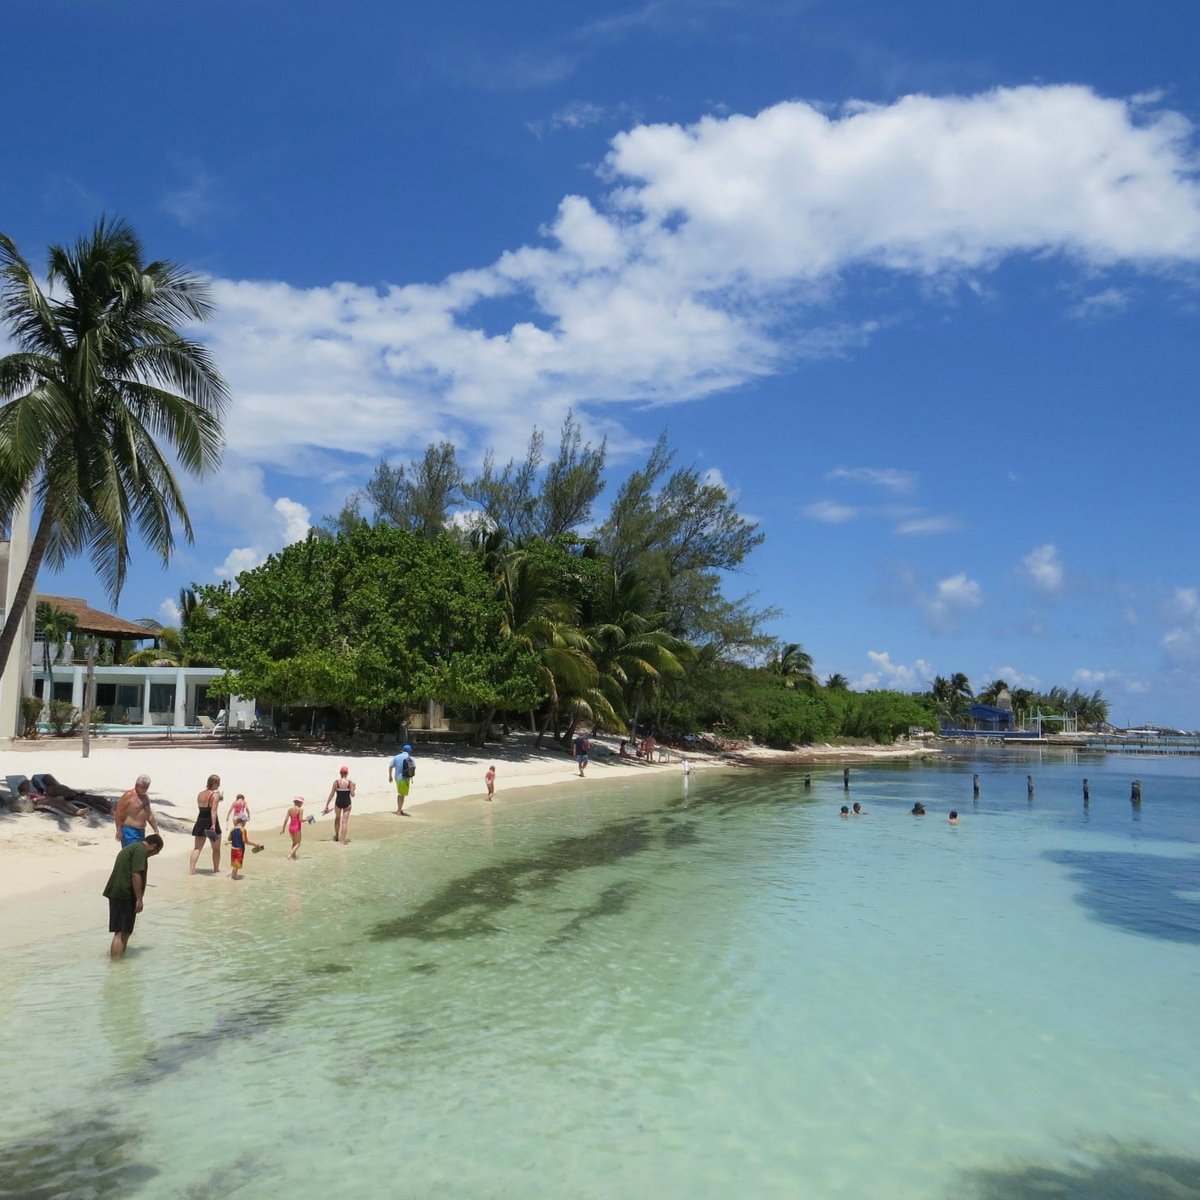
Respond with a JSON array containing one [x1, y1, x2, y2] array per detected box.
[[192, 86, 1200, 472]]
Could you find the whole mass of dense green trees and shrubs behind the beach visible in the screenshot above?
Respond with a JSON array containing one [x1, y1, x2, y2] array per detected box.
[[186, 416, 1104, 748]]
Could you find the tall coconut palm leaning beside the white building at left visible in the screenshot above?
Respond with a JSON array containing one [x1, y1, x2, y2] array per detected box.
[[0, 217, 228, 671]]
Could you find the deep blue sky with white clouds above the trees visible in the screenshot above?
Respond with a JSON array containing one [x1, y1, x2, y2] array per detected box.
[[0, 0, 1200, 727]]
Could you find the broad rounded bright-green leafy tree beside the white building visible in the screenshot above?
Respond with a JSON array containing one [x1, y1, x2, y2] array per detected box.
[[196, 524, 542, 727]]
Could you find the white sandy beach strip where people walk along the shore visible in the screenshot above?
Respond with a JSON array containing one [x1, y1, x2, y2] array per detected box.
[[0, 737, 928, 949]]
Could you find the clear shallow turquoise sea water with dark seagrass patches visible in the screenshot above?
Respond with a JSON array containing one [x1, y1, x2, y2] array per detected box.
[[0, 752, 1200, 1200]]
